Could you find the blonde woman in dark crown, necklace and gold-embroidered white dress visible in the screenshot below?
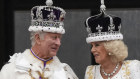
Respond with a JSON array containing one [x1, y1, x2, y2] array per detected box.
[[85, 1, 140, 79]]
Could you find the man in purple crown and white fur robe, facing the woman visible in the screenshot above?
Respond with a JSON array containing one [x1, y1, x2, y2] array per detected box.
[[0, 0, 78, 79]]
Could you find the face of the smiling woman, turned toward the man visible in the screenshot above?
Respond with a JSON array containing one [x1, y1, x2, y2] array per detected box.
[[91, 42, 109, 64]]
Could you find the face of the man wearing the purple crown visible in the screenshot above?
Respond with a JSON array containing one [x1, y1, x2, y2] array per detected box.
[[40, 33, 62, 57]]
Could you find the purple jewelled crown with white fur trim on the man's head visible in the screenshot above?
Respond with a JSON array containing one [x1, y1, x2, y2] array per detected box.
[[28, 0, 66, 34]]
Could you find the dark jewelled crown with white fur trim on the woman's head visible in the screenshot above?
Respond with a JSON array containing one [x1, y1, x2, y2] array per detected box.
[[85, 2, 123, 43]]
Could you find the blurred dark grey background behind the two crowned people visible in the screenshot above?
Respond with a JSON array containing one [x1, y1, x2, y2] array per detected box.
[[0, 0, 140, 79]]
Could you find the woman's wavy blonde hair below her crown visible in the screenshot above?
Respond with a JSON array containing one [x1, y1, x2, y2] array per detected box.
[[104, 40, 128, 62]]
